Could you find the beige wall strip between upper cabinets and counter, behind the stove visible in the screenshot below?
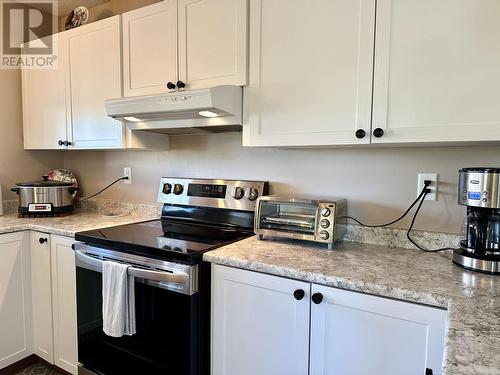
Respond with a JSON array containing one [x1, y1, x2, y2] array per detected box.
[[64, 133, 500, 233]]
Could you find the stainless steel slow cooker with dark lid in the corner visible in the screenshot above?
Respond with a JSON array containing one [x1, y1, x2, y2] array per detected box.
[[10, 176, 78, 216]]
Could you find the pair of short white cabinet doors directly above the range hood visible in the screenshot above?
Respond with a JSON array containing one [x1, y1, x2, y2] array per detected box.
[[122, 0, 248, 97]]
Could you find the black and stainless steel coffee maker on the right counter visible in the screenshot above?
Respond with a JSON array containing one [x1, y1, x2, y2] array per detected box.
[[453, 168, 500, 274]]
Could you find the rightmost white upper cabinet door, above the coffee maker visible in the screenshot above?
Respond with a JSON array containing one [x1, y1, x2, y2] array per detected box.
[[372, 0, 500, 143]]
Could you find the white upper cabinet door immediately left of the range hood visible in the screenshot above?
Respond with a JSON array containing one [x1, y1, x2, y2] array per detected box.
[[67, 16, 123, 149]]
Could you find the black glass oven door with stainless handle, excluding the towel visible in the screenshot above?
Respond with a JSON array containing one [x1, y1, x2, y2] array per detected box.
[[75, 244, 201, 375]]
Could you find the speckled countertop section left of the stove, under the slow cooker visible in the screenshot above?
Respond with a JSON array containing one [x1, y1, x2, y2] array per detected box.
[[0, 210, 160, 237]]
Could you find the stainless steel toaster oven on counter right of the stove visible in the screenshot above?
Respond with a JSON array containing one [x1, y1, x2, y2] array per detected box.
[[255, 195, 347, 249]]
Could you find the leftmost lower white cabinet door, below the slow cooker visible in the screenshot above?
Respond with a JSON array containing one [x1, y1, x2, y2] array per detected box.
[[0, 232, 33, 368]]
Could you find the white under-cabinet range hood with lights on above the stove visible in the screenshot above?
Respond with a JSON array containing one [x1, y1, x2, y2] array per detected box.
[[105, 85, 243, 134]]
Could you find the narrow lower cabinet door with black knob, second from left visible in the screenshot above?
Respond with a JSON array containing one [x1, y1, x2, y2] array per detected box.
[[30, 232, 54, 363]]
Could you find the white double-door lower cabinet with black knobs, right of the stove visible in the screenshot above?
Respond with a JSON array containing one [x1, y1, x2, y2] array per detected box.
[[211, 265, 446, 375]]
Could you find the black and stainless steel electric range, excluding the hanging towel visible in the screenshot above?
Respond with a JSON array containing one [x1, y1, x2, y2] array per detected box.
[[75, 177, 268, 375]]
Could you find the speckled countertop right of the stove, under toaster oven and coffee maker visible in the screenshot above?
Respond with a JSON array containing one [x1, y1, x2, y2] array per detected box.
[[203, 238, 500, 375]]
